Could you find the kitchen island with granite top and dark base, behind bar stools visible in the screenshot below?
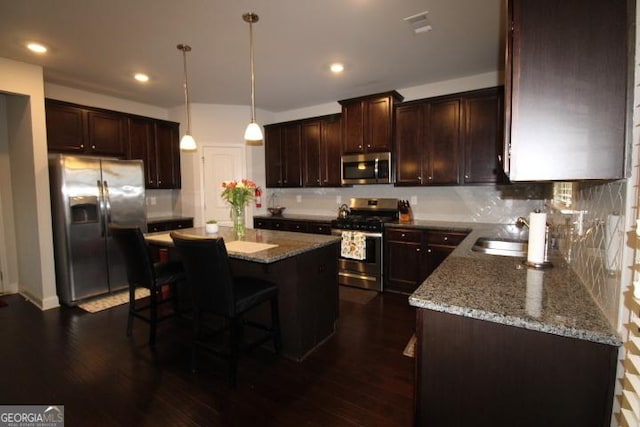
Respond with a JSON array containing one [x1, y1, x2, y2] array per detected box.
[[145, 227, 340, 361]]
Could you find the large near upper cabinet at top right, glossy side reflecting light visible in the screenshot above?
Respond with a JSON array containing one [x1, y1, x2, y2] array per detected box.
[[504, 0, 635, 181]]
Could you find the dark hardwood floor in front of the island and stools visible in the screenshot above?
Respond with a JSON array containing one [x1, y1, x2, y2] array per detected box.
[[0, 294, 415, 426]]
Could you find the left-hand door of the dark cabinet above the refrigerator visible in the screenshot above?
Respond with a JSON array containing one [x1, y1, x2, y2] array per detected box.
[[45, 100, 86, 153]]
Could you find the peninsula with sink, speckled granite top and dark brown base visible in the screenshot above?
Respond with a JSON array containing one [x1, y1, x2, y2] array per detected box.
[[409, 223, 621, 426]]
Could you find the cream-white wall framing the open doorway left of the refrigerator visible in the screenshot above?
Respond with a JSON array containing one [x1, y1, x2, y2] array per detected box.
[[0, 58, 58, 309]]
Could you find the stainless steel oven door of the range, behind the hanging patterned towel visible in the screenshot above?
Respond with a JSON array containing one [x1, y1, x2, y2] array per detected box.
[[331, 229, 382, 292]]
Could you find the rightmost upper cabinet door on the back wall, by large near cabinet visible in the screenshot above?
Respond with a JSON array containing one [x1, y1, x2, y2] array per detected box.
[[462, 89, 503, 184]]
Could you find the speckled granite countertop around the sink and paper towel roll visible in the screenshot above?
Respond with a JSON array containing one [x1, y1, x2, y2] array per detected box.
[[408, 221, 622, 346]]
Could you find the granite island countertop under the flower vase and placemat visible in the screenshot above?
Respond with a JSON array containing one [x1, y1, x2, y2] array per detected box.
[[145, 226, 341, 264]]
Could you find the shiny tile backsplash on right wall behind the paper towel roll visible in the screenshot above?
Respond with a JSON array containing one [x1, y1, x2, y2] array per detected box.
[[549, 180, 627, 325]]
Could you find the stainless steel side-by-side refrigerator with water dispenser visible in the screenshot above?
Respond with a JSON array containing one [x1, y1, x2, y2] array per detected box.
[[49, 154, 146, 305]]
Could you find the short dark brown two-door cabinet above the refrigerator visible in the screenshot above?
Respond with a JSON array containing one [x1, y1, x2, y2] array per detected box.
[[45, 99, 127, 157]]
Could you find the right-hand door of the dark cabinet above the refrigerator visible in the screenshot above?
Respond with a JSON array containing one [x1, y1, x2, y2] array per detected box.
[[86, 110, 127, 157]]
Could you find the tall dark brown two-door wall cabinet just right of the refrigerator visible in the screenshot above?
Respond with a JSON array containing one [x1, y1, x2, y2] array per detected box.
[[127, 117, 181, 189]]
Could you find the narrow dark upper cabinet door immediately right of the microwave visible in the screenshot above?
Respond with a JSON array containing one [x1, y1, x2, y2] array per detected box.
[[395, 104, 426, 185]]
